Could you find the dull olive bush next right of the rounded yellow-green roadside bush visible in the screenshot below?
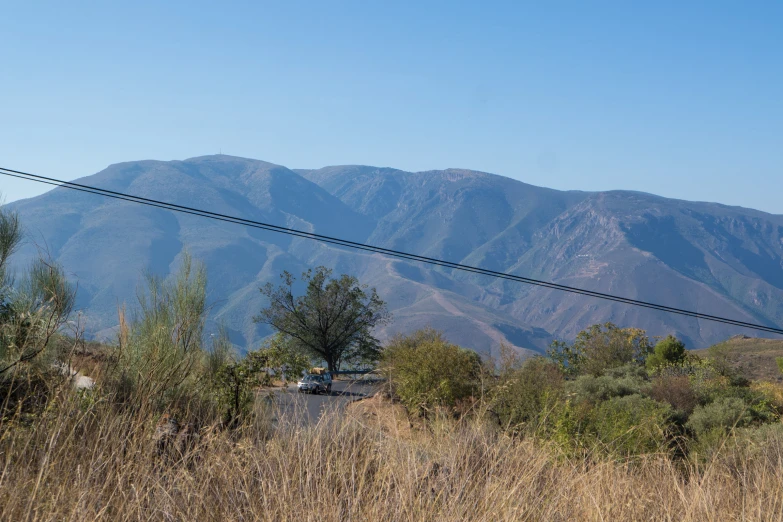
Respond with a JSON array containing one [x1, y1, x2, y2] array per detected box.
[[492, 357, 563, 432]]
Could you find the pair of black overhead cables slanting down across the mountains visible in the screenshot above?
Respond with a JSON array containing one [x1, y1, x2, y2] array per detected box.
[[0, 167, 783, 335]]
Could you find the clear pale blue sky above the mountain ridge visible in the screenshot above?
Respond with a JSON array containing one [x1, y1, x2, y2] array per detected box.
[[0, 0, 783, 214]]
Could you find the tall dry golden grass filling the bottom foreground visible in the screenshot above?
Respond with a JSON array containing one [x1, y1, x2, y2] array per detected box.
[[0, 390, 783, 522]]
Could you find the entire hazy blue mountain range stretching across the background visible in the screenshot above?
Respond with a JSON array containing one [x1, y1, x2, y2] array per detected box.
[[11, 156, 783, 354]]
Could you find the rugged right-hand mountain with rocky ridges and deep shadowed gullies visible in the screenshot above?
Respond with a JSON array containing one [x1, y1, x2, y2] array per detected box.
[[300, 166, 783, 346]]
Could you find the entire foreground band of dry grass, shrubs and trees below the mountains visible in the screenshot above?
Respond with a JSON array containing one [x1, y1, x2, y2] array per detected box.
[[0, 202, 783, 521]]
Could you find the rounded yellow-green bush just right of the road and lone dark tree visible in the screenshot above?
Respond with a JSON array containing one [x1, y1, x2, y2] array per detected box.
[[380, 328, 482, 414]]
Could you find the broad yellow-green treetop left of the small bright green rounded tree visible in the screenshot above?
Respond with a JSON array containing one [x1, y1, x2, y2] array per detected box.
[[547, 323, 652, 376]]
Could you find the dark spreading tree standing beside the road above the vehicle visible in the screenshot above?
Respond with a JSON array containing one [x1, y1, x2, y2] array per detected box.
[[254, 266, 390, 371]]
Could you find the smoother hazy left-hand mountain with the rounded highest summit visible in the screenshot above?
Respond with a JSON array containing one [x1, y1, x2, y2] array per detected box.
[[13, 156, 544, 352]]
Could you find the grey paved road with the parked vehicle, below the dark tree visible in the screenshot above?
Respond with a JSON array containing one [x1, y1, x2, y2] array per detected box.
[[266, 381, 378, 424]]
